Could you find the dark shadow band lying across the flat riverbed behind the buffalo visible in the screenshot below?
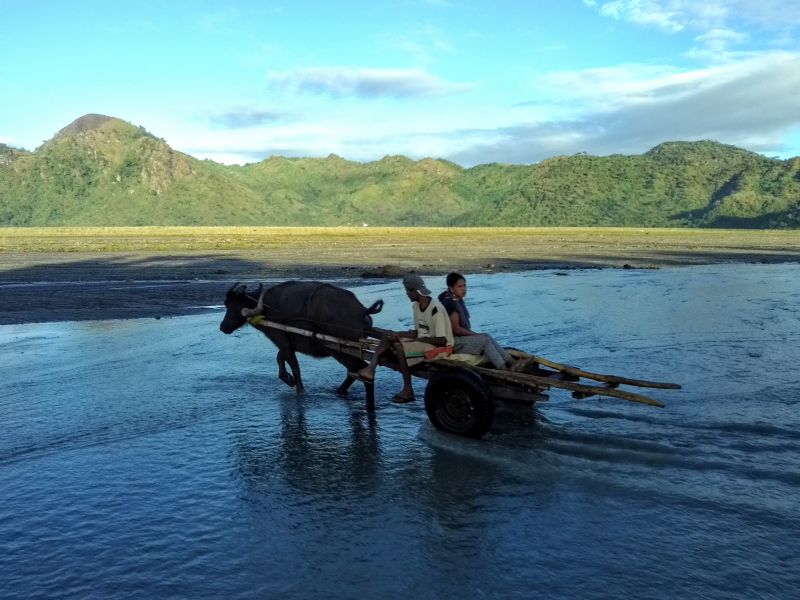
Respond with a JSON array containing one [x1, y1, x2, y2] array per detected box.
[[0, 248, 800, 324]]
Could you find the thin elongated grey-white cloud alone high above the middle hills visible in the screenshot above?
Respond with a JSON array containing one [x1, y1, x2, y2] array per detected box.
[[269, 67, 473, 98]]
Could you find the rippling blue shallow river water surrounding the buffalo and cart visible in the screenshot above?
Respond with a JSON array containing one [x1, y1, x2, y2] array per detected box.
[[0, 265, 800, 598]]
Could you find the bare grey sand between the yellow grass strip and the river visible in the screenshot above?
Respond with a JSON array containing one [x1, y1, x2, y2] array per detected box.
[[0, 235, 800, 324]]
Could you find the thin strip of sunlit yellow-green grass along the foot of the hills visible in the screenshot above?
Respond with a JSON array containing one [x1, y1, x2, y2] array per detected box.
[[0, 227, 800, 252]]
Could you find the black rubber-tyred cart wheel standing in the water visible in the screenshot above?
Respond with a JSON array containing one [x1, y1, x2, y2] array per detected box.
[[425, 367, 494, 438]]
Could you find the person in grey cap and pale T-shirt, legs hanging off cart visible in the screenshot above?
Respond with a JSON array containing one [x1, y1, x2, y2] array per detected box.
[[351, 273, 453, 404]]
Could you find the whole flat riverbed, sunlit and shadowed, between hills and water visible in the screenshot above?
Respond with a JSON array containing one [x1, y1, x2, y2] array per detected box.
[[0, 227, 800, 324]]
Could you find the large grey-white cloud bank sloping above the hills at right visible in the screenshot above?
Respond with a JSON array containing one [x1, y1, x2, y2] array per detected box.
[[451, 53, 800, 164]]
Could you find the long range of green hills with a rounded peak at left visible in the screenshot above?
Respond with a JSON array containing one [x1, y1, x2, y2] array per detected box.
[[0, 115, 800, 228]]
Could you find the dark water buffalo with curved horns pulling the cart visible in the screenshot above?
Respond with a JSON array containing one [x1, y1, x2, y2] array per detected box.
[[219, 281, 383, 404]]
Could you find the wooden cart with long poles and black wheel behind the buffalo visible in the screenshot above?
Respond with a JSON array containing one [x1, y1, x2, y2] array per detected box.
[[250, 319, 681, 438]]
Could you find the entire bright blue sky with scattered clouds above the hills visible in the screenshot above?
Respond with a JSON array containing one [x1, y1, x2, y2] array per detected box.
[[0, 0, 800, 166]]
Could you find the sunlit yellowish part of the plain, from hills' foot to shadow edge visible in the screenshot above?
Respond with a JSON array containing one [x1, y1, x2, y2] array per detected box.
[[0, 227, 800, 267]]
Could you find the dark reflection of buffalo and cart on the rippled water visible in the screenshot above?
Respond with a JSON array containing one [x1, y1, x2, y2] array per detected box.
[[228, 380, 553, 496]]
